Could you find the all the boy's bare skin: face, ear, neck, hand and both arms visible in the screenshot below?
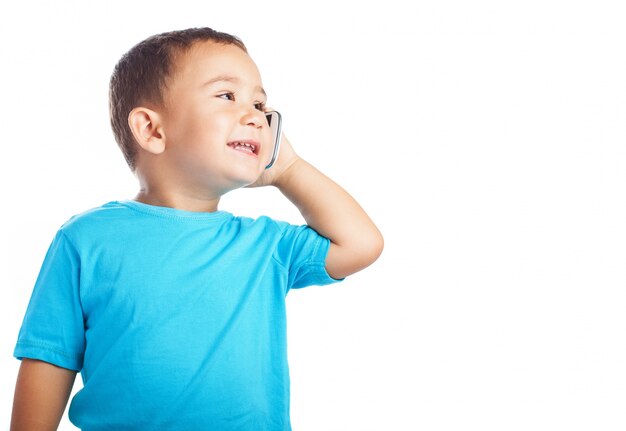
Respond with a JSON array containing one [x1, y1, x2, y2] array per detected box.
[[11, 42, 383, 431]]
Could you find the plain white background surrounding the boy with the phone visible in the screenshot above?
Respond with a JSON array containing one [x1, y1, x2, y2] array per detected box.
[[0, 0, 626, 431]]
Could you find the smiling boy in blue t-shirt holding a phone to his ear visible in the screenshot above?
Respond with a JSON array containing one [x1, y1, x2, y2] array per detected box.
[[12, 28, 383, 431]]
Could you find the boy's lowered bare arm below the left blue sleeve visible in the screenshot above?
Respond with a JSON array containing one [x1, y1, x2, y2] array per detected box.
[[11, 358, 76, 431]]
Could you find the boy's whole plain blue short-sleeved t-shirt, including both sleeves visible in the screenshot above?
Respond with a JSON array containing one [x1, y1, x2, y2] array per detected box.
[[14, 201, 336, 431]]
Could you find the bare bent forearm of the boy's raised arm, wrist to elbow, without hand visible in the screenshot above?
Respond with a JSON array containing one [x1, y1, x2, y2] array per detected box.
[[275, 158, 383, 278]]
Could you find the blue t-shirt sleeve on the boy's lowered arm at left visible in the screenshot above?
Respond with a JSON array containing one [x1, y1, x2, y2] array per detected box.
[[13, 230, 85, 371]]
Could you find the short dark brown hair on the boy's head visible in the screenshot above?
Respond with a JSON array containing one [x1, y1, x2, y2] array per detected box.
[[109, 27, 248, 171]]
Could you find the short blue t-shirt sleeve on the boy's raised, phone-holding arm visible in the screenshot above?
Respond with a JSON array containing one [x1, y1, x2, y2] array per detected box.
[[276, 224, 343, 289]]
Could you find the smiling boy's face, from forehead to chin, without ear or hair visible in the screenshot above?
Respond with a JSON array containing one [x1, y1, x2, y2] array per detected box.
[[157, 42, 273, 195]]
